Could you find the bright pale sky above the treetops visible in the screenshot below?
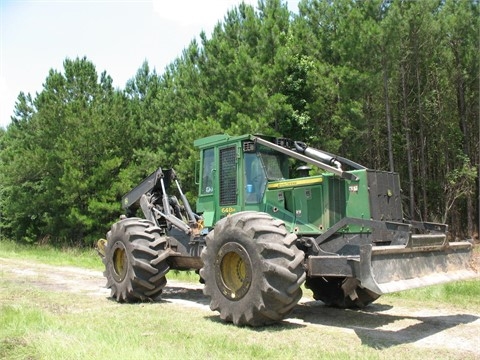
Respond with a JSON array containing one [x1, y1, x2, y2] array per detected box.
[[0, 0, 299, 128]]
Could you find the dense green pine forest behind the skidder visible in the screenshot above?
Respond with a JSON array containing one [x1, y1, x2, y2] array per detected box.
[[0, 0, 480, 246]]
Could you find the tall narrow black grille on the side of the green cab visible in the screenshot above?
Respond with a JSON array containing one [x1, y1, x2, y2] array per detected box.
[[220, 146, 237, 206]]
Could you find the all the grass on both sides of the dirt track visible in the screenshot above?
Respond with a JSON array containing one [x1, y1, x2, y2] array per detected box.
[[0, 241, 480, 359]]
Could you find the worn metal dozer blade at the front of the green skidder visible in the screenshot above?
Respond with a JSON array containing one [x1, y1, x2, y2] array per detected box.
[[356, 234, 480, 295]]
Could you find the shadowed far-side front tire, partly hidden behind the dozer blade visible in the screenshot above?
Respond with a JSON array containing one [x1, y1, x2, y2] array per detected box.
[[305, 277, 380, 309]]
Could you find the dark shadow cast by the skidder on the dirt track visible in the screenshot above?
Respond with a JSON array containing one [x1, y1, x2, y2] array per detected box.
[[108, 283, 479, 349]]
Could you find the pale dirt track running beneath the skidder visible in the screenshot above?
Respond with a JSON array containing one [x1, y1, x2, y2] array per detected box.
[[0, 258, 480, 359]]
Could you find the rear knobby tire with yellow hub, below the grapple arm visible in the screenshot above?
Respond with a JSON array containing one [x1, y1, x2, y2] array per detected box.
[[103, 218, 170, 302]]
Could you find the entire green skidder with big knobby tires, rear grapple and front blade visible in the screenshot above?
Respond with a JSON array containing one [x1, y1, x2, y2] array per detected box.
[[99, 135, 476, 326]]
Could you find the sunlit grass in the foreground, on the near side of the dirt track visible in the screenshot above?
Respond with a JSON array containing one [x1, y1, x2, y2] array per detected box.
[[0, 278, 468, 360]]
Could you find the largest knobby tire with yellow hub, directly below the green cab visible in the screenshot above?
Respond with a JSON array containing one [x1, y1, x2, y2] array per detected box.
[[200, 211, 305, 326]]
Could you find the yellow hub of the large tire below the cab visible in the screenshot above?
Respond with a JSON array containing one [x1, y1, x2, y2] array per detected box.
[[215, 242, 252, 301]]
